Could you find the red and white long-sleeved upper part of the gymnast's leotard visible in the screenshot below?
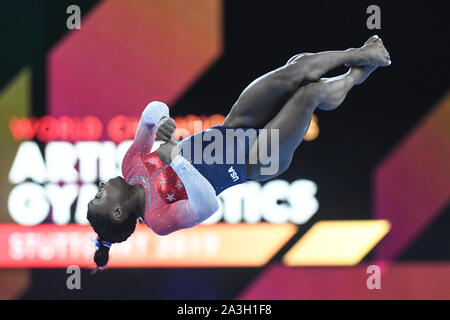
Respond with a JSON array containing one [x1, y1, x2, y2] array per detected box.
[[122, 101, 219, 235]]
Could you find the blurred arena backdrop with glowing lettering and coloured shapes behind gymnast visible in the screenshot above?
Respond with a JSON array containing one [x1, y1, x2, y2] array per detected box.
[[0, 0, 450, 299]]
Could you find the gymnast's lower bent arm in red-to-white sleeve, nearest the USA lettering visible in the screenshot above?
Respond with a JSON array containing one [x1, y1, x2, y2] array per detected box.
[[148, 155, 219, 235]]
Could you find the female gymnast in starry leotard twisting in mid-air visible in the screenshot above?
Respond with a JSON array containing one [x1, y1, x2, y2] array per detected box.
[[87, 36, 391, 267]]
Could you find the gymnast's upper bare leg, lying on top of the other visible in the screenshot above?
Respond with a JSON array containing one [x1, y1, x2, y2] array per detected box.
[[223, 36, 390, 129]]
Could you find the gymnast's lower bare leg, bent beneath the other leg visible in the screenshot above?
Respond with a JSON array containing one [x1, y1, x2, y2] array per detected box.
[[246, 62, 384, 181]]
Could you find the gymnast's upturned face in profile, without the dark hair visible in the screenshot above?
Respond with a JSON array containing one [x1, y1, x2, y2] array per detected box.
[[88, 177, 131, 219]]
